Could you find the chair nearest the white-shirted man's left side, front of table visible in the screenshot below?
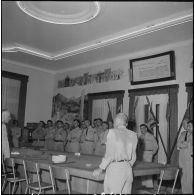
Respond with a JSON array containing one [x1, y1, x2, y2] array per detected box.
[[51, 166, 81, 194]]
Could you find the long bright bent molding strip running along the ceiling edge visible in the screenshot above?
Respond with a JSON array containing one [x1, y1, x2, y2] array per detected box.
[[2, 10, 193, 61]]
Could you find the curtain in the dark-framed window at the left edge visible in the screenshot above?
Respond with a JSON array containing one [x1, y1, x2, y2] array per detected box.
[[2, 77, 21, 119]]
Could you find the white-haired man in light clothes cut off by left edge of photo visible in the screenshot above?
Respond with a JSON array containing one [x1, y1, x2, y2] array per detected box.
[[1, 110, 11, 159]]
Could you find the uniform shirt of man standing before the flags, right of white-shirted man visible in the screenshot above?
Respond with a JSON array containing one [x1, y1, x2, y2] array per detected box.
[[140, 132, 158, 154]]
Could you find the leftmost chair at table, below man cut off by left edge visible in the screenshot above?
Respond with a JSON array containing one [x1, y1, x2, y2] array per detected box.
[[2, 158, 26, 194]]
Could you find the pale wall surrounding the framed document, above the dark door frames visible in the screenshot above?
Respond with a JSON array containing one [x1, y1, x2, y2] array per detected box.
[[54, 40, 193, 126]]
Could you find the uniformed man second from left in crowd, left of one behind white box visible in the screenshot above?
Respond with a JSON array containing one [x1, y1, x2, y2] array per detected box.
[[45, 120, 55, 150]]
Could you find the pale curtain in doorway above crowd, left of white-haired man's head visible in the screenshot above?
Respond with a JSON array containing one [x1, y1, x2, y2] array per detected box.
[[92, 98, 117, 121]]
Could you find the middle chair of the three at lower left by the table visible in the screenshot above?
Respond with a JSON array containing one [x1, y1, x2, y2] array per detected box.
[[23, 160, 55, 194]]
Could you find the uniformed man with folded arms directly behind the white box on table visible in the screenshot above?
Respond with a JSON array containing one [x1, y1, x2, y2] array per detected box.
[[54, 120, 67, 152]]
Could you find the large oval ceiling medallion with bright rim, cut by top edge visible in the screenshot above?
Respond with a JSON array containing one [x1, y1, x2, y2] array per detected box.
[[17, 1, 100, 24]]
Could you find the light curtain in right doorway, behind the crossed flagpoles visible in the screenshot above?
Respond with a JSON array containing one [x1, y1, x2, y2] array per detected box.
[[135, 94, 168, 163]]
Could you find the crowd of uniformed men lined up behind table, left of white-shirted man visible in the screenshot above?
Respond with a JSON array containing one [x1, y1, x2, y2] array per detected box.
[[32, 118, 113, 156]]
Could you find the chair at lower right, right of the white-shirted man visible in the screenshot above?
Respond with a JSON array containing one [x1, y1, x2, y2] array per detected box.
[[136, 167, 180, 194]]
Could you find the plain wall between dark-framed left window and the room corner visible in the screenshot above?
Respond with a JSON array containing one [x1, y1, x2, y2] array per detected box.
[[2, 60, 54, 124]]
